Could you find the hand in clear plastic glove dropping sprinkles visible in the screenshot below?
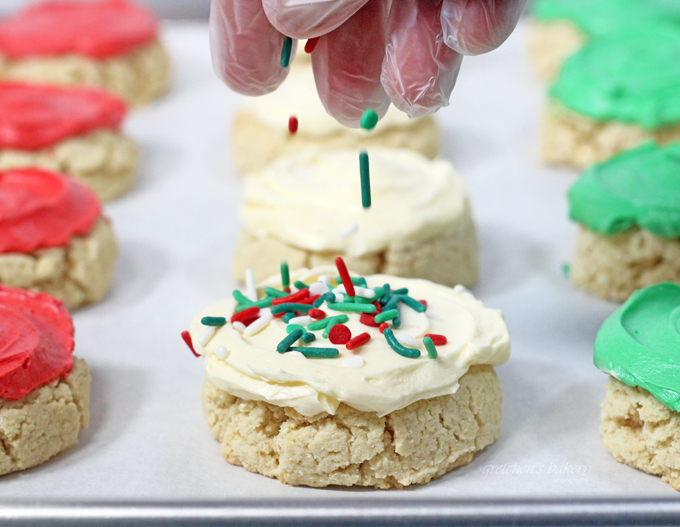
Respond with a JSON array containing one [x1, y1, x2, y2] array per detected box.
[[210, 0, 527, 127]]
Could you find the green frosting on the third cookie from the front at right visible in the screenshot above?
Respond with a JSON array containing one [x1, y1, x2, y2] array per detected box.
[[549, 25, 680, 130]]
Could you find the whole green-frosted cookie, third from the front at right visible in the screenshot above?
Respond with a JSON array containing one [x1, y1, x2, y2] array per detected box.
[[540, 25, 680, 168]]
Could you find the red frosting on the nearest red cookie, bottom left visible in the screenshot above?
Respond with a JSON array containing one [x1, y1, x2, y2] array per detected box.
[[0, 285, 75, 399]]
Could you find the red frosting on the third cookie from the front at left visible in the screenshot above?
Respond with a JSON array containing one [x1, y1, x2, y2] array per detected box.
[[0, 82, 127, 150]]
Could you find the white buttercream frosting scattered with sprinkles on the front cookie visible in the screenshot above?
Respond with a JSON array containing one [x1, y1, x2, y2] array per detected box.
[[189, 267, 510, 416]]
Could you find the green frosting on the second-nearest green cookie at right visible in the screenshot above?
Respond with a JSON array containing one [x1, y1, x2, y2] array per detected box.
[[568, 143, 680, 239]]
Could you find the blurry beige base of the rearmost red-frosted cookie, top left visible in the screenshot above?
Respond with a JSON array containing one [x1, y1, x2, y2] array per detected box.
[[0, 40, 170, 106]]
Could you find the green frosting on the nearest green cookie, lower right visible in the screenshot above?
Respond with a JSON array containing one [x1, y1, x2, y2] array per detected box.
[[593, 283, 680, 412]]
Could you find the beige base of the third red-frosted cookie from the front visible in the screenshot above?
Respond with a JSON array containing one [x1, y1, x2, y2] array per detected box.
[[0, 130, 139, 201]]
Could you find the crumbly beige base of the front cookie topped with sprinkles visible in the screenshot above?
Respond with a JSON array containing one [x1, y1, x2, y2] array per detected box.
[[202, 366, 502, 489]]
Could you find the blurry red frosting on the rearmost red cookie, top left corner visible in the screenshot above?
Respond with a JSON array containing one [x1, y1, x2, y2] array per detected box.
[[0, 0, 158, 60]]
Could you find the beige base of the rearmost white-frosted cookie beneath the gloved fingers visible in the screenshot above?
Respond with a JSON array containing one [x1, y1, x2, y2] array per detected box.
[[232, 110, 440, 174]]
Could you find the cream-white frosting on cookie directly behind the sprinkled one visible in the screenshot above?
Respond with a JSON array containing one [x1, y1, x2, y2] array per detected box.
[[240, 148, 470, 256]]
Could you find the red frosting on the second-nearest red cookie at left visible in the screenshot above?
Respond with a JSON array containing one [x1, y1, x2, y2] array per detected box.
[[0, 168, 101, 254]]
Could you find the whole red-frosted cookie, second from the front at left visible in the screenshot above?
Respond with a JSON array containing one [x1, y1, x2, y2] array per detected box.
[[0, 168, 118, 309]]
